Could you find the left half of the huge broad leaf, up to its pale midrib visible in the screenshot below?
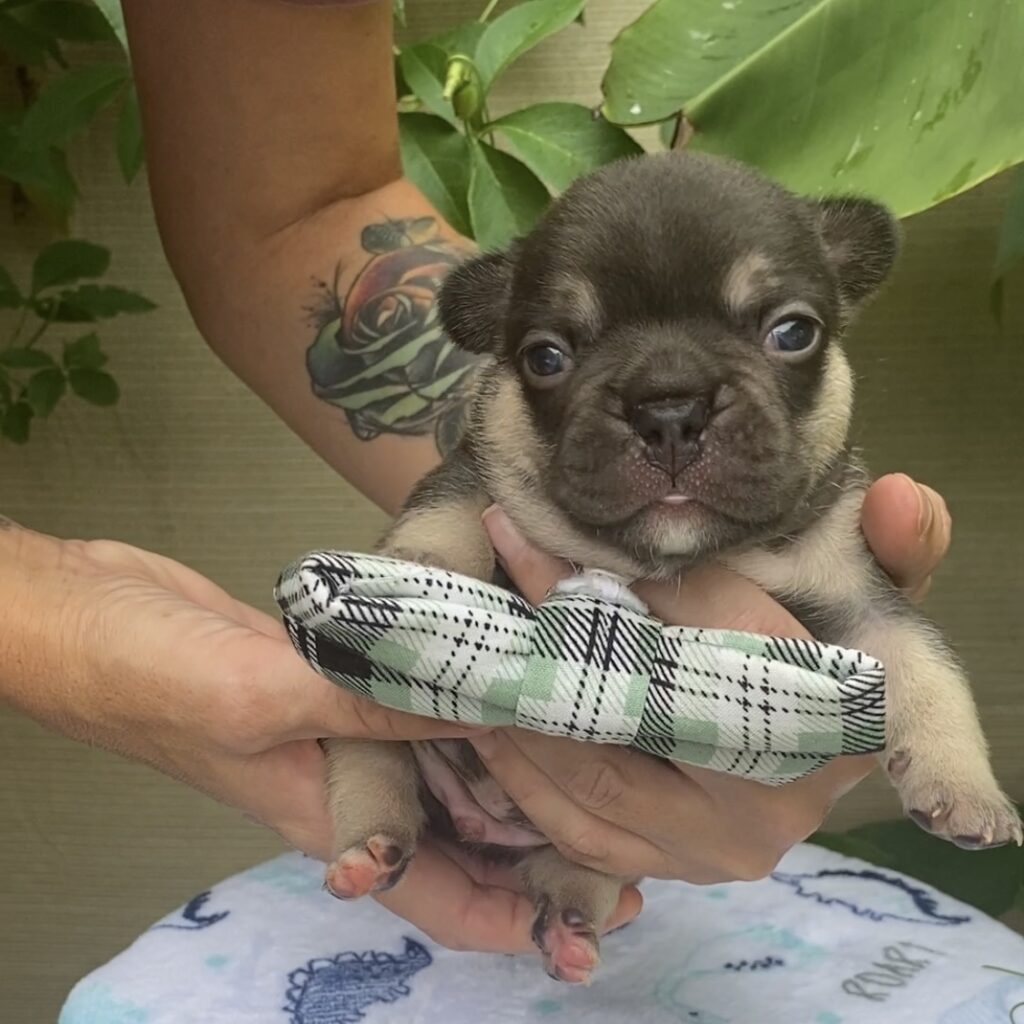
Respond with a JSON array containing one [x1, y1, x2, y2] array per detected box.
[[601, 0, 820, 124]]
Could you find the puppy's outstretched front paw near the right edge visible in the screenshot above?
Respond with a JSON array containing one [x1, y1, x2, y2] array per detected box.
[[889, 751, 1024, 850]]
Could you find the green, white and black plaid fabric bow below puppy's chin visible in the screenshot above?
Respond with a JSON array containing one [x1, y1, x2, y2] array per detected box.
[[275, 552, 885, 785]]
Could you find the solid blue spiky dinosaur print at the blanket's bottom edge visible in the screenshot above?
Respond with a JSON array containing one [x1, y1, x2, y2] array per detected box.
[[283, 938, 433, 1024]]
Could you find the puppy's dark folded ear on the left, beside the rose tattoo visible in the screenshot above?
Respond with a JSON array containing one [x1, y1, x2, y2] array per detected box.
[[437, 252, 514, 353]]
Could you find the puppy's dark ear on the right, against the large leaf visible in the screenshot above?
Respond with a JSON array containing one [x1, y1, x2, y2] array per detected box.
[[817, 196, 901, 305]]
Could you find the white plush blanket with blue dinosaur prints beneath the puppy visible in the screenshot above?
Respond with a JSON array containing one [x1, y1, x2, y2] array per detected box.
[[59, 846, 1024, 1024]]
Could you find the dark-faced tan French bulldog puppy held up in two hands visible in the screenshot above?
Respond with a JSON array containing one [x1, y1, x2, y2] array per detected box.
[[315, 153, 1022, 982]]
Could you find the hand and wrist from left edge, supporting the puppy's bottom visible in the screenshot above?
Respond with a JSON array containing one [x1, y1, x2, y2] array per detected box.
[[0, 523, 640, 952]]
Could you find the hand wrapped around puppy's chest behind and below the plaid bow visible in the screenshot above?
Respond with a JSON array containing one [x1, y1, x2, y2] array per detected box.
[[472, 475, 950, 883]]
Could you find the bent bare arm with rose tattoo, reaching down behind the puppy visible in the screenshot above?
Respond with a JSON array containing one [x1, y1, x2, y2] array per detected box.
[[124, 0, 473, 512]]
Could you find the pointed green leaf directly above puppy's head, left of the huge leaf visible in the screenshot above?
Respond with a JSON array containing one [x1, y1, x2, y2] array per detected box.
[[488, 103, 643, 191]]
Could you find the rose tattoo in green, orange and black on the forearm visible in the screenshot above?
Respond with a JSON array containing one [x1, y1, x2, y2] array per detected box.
[[306, 217, 477, 455]]
